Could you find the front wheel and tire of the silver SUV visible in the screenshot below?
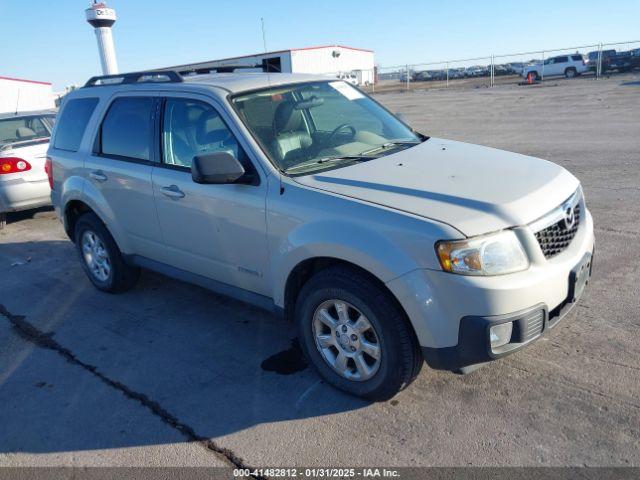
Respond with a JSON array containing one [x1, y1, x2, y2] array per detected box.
[[295, 267, 423, 401]]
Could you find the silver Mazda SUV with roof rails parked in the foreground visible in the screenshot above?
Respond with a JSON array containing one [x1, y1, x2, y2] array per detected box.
[[48, 67, 594, 399]]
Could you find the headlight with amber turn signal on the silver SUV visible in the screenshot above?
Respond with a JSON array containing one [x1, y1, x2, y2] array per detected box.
[[436, 230, 529, 275]]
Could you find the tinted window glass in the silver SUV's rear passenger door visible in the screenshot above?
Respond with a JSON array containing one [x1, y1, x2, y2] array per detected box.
[[100, 97, 155, 160]]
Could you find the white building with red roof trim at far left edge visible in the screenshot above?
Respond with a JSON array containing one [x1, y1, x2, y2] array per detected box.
[[0, 77, 55, 113]]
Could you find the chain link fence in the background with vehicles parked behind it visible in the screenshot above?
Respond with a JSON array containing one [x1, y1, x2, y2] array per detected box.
[[362, 40, 640, 92]]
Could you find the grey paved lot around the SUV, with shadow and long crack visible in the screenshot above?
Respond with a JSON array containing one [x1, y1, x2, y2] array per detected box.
[[0, 75, 640, 467]]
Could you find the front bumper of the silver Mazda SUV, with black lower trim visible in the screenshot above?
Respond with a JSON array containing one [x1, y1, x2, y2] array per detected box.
[[387, 208, 595, 370]]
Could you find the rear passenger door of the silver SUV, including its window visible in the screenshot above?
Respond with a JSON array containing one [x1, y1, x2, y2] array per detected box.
[[85, 92, 162, 259]]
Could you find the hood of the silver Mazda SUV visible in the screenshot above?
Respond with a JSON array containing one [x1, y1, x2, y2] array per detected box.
[[294, 138, 579, 236]]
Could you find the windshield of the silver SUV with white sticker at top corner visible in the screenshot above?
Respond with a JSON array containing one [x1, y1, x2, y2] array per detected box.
[[232, 81, 422, 173]]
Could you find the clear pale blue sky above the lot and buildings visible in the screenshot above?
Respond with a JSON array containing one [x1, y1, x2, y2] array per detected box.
[[0, 0, 640, 89]]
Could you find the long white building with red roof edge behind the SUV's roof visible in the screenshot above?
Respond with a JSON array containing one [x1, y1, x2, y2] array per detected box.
[[164, 45, 375, 85]]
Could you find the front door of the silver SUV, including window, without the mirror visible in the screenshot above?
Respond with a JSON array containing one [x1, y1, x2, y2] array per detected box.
[[153, 97, 269, 295]]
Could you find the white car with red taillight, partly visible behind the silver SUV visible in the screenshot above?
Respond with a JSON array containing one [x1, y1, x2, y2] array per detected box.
[[0, 110, 56, 228]]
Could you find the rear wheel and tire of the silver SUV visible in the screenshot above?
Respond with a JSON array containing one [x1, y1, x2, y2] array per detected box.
[[74, 212, 140, 293]]
